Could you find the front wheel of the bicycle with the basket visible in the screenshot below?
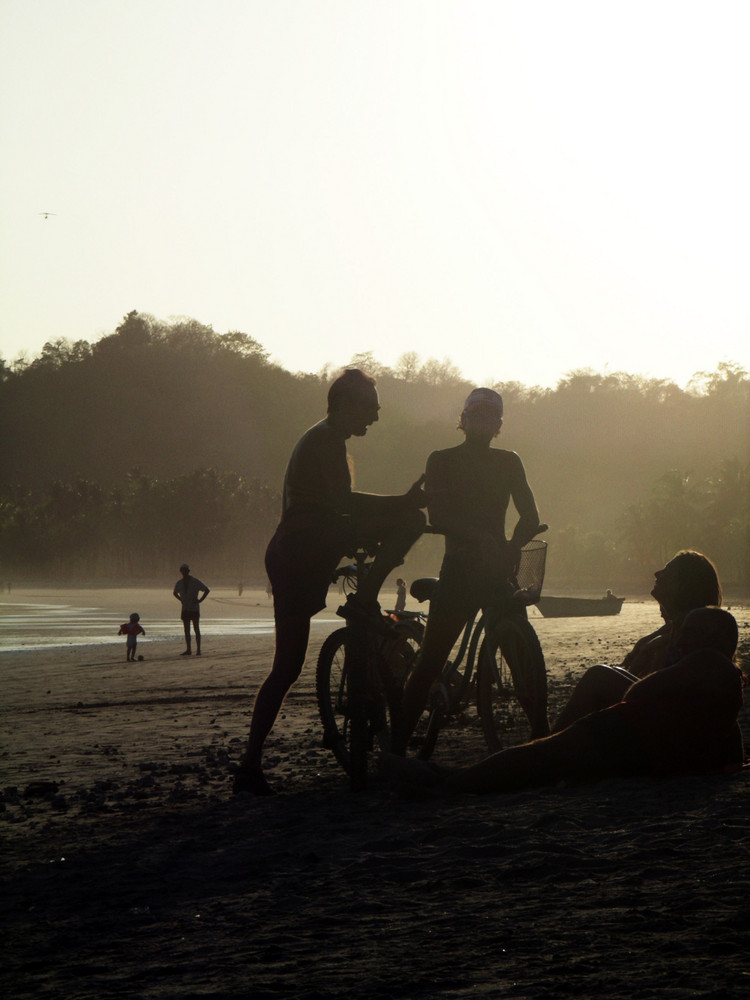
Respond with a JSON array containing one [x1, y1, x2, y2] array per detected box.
[[477, 618, 549, 753]]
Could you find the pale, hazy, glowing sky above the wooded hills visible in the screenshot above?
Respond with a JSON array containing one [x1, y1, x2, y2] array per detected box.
[[0, 0, 750, 385]]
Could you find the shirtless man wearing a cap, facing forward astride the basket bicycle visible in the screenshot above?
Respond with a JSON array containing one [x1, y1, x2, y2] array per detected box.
[[392, 388, 543, 755]]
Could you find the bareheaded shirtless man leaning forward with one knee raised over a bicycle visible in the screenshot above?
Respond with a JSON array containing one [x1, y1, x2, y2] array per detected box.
[[233, 368, 426, 795]]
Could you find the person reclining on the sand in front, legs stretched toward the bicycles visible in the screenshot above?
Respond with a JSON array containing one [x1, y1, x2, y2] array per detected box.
[[383, 608, 745, 795]]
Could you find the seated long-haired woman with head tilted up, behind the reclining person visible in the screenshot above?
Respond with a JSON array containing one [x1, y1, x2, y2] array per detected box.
[[552, 549, 721, 733]]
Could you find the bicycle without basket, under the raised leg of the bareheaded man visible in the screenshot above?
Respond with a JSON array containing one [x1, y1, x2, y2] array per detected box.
[[315, 546, 426, 791]]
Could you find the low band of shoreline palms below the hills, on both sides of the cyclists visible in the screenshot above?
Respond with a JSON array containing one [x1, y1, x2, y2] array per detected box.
[[0, 460, 750, 590]]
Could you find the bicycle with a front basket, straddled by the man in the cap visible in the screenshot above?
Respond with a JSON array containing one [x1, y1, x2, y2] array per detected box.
[[410, 525, 549, 760]]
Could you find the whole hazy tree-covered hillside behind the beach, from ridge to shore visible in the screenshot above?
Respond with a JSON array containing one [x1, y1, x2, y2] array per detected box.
[[0, 312, 750, 589]]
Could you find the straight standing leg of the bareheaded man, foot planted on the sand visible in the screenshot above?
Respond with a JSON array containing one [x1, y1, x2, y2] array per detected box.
[[235, 618, 310, 794]]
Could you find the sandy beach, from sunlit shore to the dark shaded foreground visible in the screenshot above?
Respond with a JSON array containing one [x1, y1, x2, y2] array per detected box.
[[0, 589, 750, 1000]]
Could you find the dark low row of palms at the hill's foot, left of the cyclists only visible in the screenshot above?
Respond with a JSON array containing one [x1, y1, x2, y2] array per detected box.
[[0, 469, 280, 583]]
